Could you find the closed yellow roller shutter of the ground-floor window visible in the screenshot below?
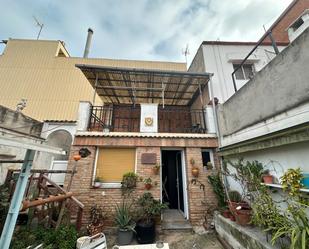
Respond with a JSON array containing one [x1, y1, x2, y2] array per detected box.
[[96, 148, 135, 183]]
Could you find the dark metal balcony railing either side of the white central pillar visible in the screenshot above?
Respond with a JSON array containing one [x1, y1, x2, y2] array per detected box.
[[88, 106, 207, 133]]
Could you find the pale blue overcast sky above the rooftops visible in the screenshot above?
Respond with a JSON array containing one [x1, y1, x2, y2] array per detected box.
[[0, 0, 291, 64]]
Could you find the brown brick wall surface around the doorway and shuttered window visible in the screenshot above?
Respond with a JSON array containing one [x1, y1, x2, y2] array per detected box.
[[65, 138, 218, 229]]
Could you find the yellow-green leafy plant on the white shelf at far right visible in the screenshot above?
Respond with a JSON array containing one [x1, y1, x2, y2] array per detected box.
[[280, 168, 303, 196]]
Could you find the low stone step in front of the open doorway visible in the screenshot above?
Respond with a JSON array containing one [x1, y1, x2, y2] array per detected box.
[[162, 209, 192, 231]]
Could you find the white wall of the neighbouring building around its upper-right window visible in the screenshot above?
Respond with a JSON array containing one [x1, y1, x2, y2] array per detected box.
[[202, 44, 285, 103]]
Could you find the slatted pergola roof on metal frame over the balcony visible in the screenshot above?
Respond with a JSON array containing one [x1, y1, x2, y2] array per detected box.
[[76, 64, 212, 107]]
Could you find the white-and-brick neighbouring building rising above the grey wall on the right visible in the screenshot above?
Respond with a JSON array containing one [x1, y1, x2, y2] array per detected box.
[[189, 0, 309, 103]]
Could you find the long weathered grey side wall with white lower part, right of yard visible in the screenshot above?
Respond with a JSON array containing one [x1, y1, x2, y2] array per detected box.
[[217, 28, 309, 192]]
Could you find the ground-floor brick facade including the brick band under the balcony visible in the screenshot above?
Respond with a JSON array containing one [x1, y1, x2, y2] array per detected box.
[[66, 137, 219, 228]]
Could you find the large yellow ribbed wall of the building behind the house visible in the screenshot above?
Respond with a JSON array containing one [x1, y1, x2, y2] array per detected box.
[[0, 39, 186, 121]]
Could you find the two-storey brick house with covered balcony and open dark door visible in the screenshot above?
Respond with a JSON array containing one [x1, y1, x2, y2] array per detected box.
[[64, 64, 219, 228]]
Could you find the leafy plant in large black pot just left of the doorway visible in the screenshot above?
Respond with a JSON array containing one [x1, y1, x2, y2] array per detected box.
[[135, 192, 168, 244]]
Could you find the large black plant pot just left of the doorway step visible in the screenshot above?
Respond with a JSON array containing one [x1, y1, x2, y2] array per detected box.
[[135, 220, 156, 244]]
